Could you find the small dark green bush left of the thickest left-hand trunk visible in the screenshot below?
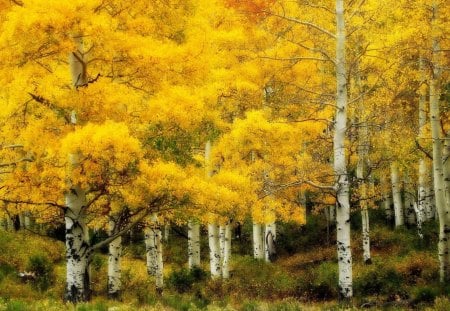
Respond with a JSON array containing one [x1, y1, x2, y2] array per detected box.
[[27, 255, 54, 291]]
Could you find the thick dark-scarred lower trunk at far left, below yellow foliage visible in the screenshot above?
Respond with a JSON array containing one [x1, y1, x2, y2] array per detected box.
[[64, 187, 91, 302]]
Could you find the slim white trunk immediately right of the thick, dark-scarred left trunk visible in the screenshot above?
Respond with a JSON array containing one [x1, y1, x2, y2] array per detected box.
[[108, 219, 122, 299]]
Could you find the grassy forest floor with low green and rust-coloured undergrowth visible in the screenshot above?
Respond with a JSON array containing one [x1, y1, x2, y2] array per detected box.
[[0, 216, 450, 311]]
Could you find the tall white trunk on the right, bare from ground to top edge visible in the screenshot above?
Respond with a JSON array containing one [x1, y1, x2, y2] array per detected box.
[[333, 0, 353, 299]]
